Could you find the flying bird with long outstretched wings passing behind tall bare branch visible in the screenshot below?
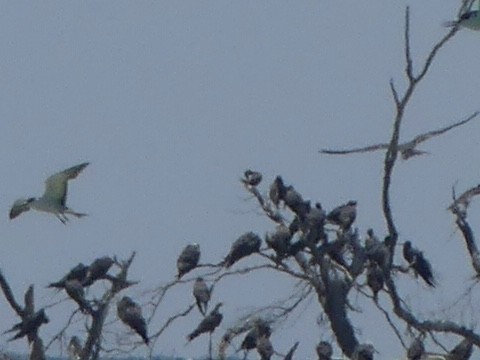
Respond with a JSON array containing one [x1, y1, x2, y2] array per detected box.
[[319, 112, 479, 160]]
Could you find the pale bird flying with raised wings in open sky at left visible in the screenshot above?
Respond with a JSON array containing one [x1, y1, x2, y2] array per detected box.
[[10, 162, 89, 224]]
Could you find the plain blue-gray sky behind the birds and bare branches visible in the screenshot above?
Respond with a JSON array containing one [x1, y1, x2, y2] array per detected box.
[[0, 0, 480, 359]]
